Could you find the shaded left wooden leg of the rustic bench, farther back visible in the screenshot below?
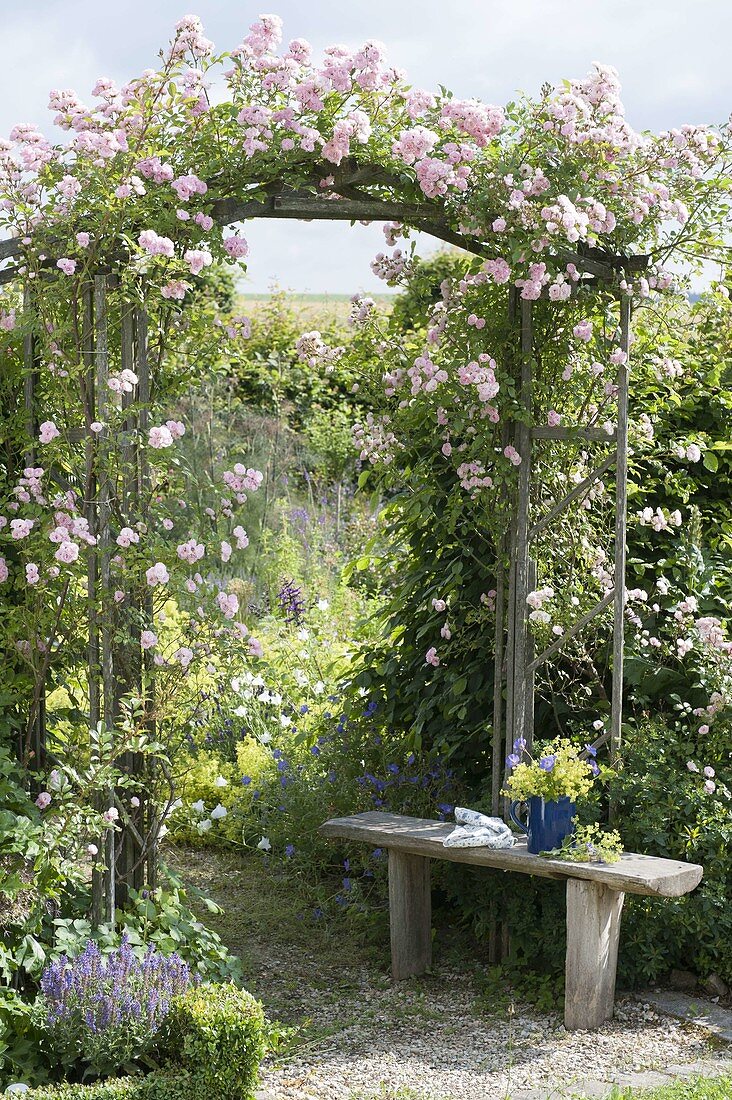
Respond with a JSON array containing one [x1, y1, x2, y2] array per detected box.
[[389, 848, 433, 981]]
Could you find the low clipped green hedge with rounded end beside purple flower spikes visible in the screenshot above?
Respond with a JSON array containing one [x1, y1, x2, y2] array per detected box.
[[21, 985, 266, 1100]]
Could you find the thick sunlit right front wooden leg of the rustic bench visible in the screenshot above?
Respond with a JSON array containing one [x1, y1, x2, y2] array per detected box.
[[565, 879, 625, 1031]]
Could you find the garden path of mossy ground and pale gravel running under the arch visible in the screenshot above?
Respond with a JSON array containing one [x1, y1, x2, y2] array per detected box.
[[179, 849, 732, 1100]]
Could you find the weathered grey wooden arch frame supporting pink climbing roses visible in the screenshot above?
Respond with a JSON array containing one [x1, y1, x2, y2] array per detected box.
[[0, 160, 647, 921]]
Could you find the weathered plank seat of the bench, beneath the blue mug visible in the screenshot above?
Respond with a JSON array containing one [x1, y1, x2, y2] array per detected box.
[[320, 811, 703, 898]]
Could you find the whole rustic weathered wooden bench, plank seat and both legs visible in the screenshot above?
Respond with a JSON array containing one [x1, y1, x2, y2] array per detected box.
[[320, 811, 703, 1030]]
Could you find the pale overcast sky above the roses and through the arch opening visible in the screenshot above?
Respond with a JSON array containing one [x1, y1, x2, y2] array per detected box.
[[0, 0, 732, 294]]
